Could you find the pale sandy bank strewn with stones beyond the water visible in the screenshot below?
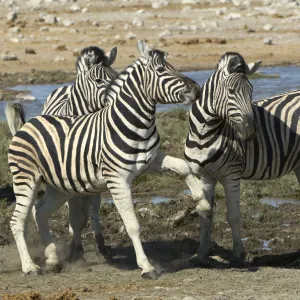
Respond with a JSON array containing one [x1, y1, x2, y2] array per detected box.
[[0, 0, 300, 77]]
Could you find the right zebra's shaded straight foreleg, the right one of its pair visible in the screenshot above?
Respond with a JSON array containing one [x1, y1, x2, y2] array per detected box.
[[223, 179, 246, 267]]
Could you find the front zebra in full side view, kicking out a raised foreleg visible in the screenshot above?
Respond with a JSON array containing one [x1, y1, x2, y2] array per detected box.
[[8, 41, 203, 278]]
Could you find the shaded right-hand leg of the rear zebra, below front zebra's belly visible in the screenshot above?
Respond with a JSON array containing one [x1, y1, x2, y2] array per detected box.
[[89, 195, 112, 259]]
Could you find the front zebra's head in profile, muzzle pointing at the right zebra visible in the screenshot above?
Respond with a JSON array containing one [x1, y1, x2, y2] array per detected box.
[[137, 41, 201, 104]]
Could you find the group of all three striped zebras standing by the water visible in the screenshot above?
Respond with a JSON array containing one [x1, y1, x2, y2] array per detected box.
[[6, 41, 300, 278]]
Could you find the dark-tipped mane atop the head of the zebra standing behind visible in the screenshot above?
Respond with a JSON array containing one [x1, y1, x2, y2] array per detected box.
[[75, 46, 107, 74]]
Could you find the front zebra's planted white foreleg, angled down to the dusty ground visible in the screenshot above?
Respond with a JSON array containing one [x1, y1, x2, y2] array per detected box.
[[108, 182, 157, 279]]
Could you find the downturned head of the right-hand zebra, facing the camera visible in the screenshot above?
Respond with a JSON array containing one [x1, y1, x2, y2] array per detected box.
[[213, 52, 261, 140]]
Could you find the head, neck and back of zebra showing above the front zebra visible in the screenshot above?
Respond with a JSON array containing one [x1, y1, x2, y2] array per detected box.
[[42, 47, 118, 116]]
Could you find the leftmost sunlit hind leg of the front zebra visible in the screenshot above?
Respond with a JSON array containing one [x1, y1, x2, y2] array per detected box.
[[10, 178, 41, 274]]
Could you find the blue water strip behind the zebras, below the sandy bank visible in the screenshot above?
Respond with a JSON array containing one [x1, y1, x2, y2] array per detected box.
[[0, 66, 300, 120]]
